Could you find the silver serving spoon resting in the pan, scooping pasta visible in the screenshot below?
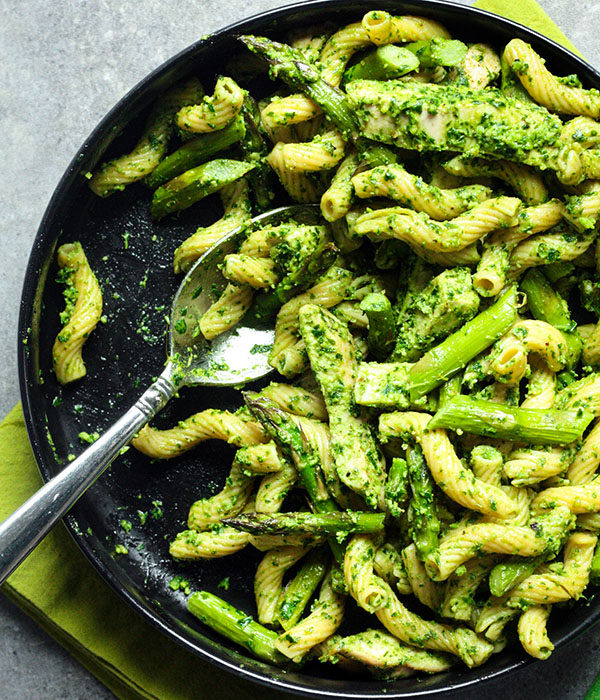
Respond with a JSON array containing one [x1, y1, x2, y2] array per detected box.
[[0, 205, 319, 584]]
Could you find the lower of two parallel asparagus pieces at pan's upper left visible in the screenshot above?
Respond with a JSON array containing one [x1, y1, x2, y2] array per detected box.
[[152, 158, 255, 219]]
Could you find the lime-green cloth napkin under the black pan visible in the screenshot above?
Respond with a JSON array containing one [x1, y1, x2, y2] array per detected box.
[[0, 0, 600, 700]]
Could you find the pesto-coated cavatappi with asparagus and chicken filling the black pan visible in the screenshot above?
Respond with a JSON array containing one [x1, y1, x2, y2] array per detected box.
[[69, 9, 600, 679]]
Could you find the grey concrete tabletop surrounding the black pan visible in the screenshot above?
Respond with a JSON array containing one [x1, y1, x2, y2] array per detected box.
[[0, 0, 600, 700]]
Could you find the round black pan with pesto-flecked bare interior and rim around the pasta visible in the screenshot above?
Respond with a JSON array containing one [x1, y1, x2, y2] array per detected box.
[[19, 0, 600, 698]]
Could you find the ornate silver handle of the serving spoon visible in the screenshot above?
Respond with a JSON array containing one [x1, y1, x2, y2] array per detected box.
[[0, 363, 175, 584]]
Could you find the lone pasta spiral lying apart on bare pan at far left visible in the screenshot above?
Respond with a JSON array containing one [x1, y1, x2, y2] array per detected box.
[[52, 241, 102, 384]]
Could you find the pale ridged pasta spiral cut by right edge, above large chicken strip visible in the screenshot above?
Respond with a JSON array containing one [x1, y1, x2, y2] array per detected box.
[[504, 39, 600, 118]]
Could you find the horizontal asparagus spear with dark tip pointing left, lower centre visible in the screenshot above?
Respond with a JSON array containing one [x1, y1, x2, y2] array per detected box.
[[221, 511, 385, 535]]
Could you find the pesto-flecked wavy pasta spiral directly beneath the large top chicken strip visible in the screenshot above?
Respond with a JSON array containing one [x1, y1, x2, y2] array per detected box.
[[352, 164, 492, 221]]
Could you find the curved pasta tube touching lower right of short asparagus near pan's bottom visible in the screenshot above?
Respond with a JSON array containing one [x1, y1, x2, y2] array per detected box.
[[273, 572, 345, 663]]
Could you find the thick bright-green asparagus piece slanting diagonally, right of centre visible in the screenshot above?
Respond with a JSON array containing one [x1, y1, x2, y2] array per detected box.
[[408, 286, 517, 401]]
